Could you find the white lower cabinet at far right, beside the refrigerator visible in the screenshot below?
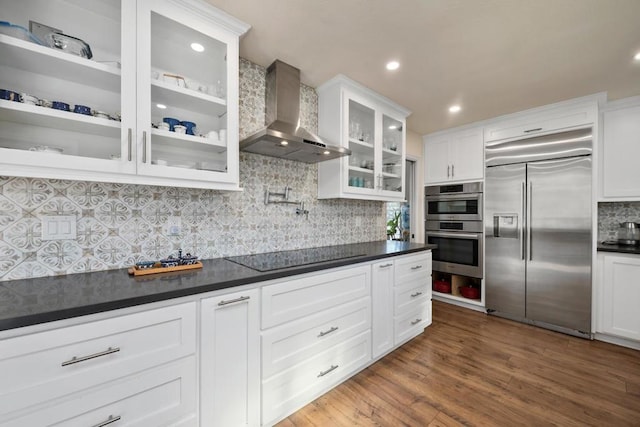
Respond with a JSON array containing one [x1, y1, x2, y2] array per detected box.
[[598, 252, 640, 341]]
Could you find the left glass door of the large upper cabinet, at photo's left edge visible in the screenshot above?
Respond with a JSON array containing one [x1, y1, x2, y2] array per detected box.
[[0, 0, 135, 176]]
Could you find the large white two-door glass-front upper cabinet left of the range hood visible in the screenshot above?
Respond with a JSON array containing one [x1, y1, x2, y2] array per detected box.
[[0, 0, 248, 190]]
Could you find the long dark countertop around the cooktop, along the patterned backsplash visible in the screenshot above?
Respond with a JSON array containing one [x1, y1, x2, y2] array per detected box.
[[0, 241, 436, 331]]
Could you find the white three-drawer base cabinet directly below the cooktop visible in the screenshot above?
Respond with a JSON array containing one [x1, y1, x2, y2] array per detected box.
[[261, 264, 371, 425]]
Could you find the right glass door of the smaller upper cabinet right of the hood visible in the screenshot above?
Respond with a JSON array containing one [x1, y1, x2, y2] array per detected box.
[[380, 114, 405, 193]]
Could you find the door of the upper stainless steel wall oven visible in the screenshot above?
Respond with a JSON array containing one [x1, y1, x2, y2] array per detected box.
[[425, 193, 482, 221]]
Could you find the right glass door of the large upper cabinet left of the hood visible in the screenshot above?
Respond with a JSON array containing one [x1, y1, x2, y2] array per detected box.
[[138, 1, 232, 180]]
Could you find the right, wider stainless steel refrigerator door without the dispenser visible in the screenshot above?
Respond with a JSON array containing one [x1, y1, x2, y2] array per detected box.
[[524, 157, 592, 332]]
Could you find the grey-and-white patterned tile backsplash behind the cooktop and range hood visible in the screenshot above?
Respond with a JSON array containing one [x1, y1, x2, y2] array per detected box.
[[0, 59, 386, 281]]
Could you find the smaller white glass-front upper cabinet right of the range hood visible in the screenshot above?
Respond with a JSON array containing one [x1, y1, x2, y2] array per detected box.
[[317, 75, 410, 201]]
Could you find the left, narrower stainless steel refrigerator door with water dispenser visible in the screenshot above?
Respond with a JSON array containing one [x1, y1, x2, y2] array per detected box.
[[484, 164, 526, 318]]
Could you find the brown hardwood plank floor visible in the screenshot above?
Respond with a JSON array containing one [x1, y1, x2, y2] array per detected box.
[[278, 301, 640, 427]]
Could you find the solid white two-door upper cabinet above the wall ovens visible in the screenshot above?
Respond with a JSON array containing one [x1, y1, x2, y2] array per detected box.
[[424, 128, 484, 185]]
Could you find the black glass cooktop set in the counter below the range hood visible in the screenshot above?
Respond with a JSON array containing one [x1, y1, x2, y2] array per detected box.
[[225, 247, 365, 272]]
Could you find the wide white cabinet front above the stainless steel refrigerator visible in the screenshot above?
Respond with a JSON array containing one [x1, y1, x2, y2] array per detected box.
[[484, 102, 597, 142]]
